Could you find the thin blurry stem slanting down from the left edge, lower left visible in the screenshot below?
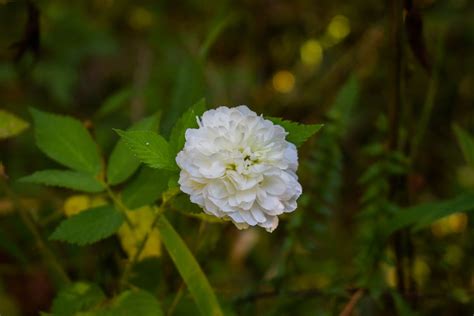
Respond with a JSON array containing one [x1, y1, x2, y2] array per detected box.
[[0, 172, 71, 284]]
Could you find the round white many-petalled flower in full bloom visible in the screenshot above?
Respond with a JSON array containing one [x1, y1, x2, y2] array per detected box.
[[176, 105, 302, 232]]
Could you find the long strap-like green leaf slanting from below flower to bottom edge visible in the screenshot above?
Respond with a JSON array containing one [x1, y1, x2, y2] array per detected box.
[[157, 215, 223, 316]]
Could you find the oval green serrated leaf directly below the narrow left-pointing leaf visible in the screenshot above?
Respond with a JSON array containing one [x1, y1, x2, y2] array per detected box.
[[50, 205, 123, 246]]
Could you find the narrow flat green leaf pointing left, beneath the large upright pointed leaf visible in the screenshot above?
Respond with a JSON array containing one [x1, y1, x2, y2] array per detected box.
[[19, 170, 104, 193]]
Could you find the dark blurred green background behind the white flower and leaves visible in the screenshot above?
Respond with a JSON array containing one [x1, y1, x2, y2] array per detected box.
[[0, 0, 474, 315]]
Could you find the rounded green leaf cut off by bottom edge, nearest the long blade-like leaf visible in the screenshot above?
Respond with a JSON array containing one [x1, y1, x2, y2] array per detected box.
[[97, 290, 163, 316]]
